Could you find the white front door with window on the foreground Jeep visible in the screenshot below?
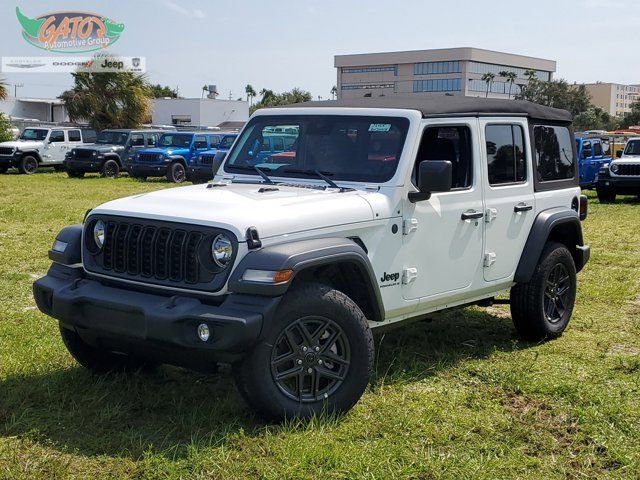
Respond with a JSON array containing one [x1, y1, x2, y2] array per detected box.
[[402, 119, 484, 300]]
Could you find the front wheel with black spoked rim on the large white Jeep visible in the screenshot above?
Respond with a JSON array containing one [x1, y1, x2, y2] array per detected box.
[[236, 284, 374, 420]]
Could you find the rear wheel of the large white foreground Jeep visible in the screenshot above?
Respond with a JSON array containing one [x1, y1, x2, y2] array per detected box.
[[510, 242, 577, 341]]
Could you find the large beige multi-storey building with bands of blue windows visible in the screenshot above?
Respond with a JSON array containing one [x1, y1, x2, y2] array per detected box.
[[334, 48, 556, 98]]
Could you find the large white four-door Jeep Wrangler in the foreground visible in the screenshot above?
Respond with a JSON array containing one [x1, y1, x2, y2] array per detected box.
[[34, 97, 589, 418]]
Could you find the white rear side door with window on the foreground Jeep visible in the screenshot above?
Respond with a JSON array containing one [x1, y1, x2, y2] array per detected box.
[[480, 119, 536, 282]]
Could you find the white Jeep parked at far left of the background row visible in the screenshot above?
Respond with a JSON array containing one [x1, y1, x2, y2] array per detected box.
[[0, 127, 96, 174]]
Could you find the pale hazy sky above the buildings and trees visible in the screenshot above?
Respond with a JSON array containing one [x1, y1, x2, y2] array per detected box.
[[0, 0, 640, 99]]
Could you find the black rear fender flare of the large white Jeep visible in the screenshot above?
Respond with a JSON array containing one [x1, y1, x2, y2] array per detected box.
[[513, 207, 589, 283]]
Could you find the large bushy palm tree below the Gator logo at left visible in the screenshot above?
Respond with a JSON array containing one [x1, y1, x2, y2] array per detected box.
[[60, 68, 151, 130]]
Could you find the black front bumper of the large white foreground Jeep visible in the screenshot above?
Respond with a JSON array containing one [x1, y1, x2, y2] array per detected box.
[[33, 263, 280, 368]]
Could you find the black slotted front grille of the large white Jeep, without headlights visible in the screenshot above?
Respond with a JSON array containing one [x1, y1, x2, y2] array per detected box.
[[83, 216, 237, 291]]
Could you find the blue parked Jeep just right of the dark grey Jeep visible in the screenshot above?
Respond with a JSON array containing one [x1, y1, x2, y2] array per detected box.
[[125, 132, 220, 183]]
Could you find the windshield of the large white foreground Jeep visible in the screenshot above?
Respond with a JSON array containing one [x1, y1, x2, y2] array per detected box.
[[224, 115, 409, 183]]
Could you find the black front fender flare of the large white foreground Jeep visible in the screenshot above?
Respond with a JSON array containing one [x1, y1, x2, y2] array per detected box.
[[228, 238, 385, 321]]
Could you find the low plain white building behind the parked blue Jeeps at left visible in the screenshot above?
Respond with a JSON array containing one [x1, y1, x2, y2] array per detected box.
[[151, 98, 249, 127]]
